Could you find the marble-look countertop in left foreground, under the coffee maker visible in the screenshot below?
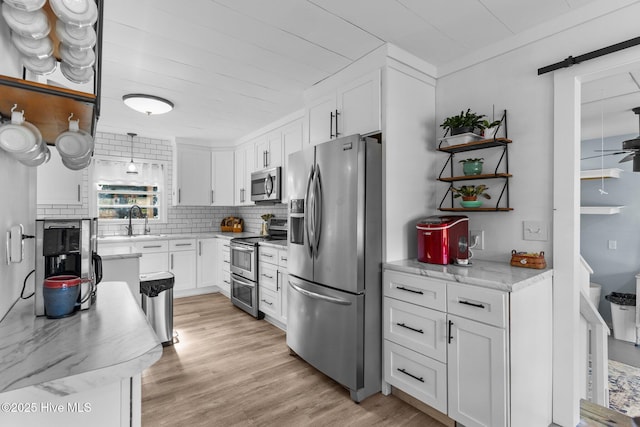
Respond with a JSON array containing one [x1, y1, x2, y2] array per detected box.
[[0, 282, 162, 396]]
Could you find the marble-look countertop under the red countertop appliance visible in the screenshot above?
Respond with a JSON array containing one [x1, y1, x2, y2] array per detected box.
[[384, 258, 553, 292]]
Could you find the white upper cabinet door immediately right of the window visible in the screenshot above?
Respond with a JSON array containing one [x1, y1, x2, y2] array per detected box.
[[174, 147, 211, 206]]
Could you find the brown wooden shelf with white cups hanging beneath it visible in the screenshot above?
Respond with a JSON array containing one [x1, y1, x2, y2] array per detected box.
[[0, 75, 96, 145]]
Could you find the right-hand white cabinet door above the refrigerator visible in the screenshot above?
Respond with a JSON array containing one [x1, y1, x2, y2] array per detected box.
[[338, 70, 382, 136]]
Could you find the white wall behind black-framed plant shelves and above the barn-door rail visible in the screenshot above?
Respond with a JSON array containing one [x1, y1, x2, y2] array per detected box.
[[436, 3, 640, 261]]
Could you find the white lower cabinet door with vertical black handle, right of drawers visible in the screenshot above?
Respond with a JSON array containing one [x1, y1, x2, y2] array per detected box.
[[447, 315, 508, 427]]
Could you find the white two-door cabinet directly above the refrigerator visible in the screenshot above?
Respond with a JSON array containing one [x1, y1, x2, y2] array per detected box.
[[305, 69, 382, 145]]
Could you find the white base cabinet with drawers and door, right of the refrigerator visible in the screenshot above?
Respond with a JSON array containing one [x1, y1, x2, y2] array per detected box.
[[383, 270, 552, 427]]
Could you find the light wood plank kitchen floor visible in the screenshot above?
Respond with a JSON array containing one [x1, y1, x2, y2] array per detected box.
[[142, 294, 443, 427]]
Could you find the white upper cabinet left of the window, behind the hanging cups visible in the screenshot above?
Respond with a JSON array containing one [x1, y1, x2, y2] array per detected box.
[[36, 147, 83, 205]]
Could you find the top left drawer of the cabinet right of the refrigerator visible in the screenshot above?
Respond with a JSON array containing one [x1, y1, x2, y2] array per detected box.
[[383, 270, 447, 311]]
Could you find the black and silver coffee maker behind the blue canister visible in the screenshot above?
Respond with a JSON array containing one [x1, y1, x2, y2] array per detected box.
[[35, 218, 102, 316]]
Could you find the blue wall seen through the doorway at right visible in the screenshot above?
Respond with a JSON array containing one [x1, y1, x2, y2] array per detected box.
[[584, 134, 640, 323]]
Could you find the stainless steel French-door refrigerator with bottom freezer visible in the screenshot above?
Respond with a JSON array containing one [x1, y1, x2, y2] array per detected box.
[[287, 135, 382, 402]]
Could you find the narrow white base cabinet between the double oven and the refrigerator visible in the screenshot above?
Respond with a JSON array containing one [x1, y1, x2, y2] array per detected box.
[[258, 245, 289, 328]]
